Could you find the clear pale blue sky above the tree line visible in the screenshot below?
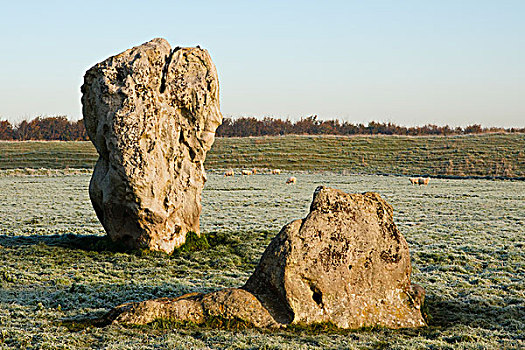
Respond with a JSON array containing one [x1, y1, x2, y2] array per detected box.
[[0, 0, 525, 127]]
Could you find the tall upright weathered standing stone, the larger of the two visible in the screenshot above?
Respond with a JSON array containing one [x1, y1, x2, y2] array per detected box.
[[82, 39, 222, 253]]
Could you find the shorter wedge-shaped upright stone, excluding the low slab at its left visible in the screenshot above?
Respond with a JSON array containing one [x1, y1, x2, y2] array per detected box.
[[244, 187, 425, 328]]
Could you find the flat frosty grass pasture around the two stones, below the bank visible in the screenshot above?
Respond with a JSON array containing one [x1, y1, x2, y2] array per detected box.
[[0, 173, 525, 349]]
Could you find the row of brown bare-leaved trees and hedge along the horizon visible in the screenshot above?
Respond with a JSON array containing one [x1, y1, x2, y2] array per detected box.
[[0, 116, 525, 141]]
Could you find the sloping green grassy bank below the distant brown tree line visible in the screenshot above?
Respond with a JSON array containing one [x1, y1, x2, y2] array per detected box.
[[0, 134, 525, 178]]
